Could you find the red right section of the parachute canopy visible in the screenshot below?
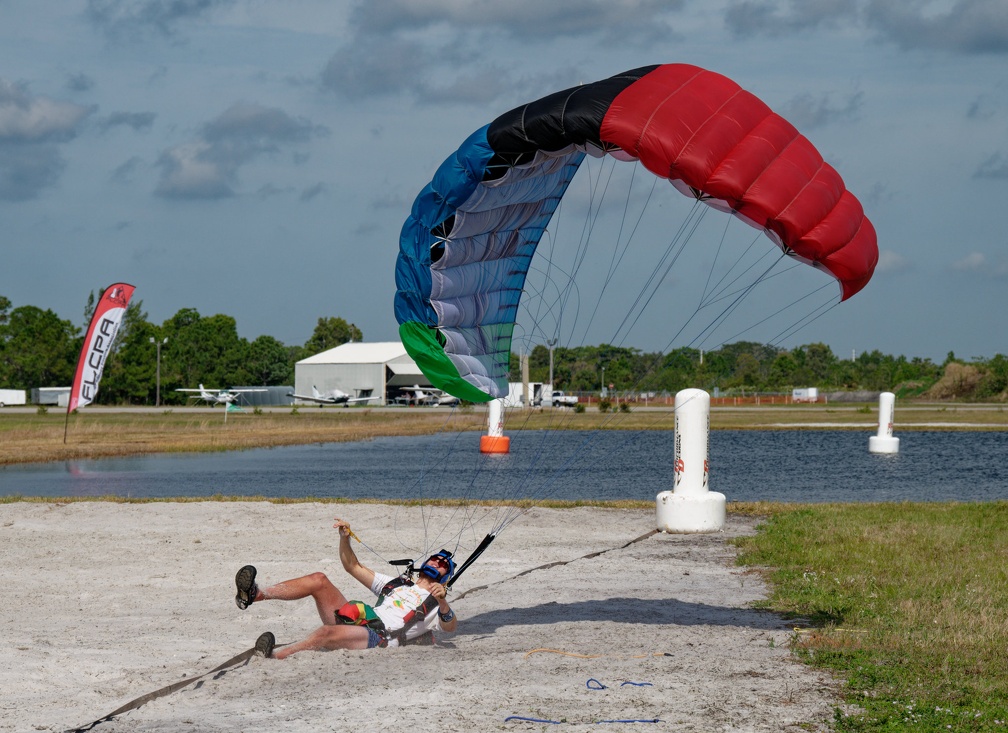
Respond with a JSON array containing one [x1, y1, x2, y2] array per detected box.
[[601, 64, 878, 300]]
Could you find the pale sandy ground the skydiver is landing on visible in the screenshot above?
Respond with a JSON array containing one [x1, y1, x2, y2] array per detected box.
[[0, 502, 837, 733]]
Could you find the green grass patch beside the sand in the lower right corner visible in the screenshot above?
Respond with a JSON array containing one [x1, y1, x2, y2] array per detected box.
[[737, 501, 1008, 733]]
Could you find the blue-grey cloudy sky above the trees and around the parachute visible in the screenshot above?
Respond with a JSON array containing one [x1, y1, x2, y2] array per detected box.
[[0, 0, 1008, 362]]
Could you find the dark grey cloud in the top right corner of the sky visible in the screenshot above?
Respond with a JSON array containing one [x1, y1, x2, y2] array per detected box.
[[865, 0, 1008, 53]]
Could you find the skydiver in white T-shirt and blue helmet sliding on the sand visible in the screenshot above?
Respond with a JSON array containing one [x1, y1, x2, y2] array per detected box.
[[235, 517, 459, 659]]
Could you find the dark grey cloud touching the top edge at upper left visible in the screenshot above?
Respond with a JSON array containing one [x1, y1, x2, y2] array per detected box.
[[85, 0, 236, 38]]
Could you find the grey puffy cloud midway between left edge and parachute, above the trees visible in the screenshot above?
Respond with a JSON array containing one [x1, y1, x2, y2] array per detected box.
[[155, 102, 329, 199]]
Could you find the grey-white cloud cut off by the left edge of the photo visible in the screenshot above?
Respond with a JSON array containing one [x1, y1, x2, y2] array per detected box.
[[0, 79, 94, 201]]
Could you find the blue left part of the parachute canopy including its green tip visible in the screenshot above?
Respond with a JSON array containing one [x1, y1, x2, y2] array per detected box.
[[395, 127, 585, 401]]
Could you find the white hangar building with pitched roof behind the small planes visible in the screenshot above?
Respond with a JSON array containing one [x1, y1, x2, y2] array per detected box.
[[294, 341, 431, 405]]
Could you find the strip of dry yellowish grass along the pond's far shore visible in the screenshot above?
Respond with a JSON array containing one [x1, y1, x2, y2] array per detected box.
[[0, 404, 1008, 465]]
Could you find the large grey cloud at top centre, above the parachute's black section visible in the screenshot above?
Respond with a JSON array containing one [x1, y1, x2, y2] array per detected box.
[[322, 0, 684, 104]]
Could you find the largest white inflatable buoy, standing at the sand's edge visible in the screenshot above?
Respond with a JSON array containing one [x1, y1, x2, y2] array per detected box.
[[655, 389, 727, 532]]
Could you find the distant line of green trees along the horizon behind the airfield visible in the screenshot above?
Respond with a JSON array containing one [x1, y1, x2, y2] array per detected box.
[[0, 292, 1008, 405]]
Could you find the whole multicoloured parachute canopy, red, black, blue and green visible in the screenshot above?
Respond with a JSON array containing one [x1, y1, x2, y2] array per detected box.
[[395, 64, 878, 402]]
